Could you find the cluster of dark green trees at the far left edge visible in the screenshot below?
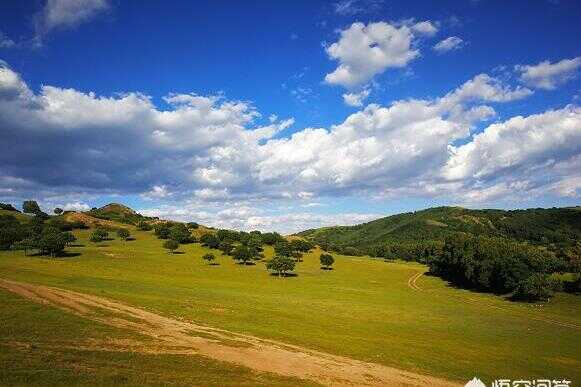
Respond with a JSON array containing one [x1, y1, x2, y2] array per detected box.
[[0, 200, 77, 257]]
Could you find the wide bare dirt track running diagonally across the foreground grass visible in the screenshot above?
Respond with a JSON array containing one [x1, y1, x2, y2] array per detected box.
[[0, 279, 460, 387]]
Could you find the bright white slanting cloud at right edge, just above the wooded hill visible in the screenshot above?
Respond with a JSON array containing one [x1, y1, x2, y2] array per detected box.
[[443, 106, 581, 185]]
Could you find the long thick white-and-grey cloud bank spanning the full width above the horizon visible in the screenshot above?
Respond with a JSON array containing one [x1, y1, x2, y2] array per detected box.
[[0, 60, 581, 228]]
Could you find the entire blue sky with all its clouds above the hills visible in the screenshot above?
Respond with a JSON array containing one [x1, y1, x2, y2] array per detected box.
[[0, 0, 581, 232]]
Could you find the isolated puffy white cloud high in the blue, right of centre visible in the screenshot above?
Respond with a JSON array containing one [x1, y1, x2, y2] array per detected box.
[[325, 22, 435, 88]]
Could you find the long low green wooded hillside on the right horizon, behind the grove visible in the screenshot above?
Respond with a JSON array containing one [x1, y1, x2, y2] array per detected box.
[[297, 207, 581, 255]]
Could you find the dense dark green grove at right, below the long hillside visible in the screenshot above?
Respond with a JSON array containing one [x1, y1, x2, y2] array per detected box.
[[427, 234, 579, 301]]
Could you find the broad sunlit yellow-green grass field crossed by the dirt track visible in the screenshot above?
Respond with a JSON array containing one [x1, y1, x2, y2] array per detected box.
[[0, 227, 581, 384]]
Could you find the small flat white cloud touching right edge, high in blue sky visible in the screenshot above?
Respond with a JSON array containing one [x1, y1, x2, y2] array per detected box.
[[515, 56, 581, 90]]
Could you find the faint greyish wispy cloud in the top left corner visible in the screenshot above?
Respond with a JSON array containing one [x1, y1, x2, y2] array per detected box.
[[35, 0, 110, 44]]
